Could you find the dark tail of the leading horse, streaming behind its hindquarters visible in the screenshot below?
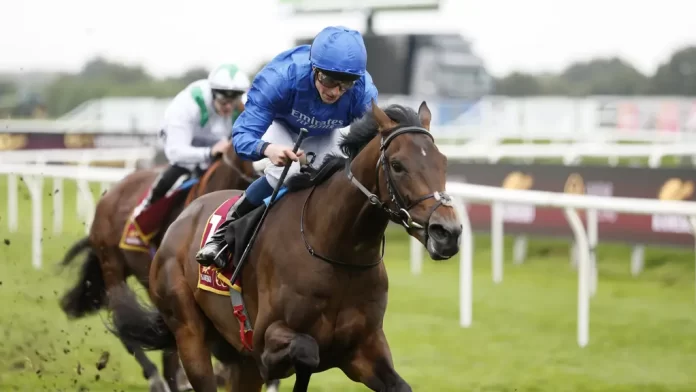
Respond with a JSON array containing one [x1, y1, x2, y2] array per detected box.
[[107, 282, 176, 350]]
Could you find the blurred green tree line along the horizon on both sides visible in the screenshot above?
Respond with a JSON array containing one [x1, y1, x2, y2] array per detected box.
[[0, 46, 696, 117]]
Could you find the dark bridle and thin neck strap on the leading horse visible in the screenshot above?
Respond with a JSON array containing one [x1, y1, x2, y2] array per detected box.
[[300, 126, 452, 269]]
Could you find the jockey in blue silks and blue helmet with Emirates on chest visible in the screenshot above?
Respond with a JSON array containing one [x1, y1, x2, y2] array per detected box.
[[196, 27, 378, 268]]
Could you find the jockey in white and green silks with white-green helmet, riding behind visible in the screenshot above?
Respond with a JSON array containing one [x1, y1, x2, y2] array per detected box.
[[135, 64, 251, 215]]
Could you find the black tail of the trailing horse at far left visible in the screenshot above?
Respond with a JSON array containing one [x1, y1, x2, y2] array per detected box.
[[60, 237, 106, 319]]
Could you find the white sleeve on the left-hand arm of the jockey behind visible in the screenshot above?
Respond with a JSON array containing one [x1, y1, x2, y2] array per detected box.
[[164, 91, 210, 164]]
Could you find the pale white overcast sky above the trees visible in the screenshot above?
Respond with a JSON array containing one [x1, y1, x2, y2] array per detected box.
[[5, 0, 696, 76]]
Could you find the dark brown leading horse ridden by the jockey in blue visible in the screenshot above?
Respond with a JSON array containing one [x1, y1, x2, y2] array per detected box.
[[107, 102, 461, 392]]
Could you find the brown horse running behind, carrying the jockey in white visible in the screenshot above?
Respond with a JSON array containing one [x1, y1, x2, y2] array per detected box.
[[60, 144, 258, 391]]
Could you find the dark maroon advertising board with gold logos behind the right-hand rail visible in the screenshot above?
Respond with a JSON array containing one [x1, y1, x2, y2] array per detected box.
[[448, 162, 696, 247]]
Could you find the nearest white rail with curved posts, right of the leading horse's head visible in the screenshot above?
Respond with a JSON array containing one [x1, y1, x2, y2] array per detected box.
[[411, 182, 696, 347]]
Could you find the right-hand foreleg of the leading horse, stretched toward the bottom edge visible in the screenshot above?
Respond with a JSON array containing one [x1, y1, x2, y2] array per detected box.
[[341, 329, 411, 392]]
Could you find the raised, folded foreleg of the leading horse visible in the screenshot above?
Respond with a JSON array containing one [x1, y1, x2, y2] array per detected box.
[[261, 321, 319, 391]]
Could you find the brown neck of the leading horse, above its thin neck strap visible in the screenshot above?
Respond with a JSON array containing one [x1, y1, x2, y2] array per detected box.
[[305, 144, 389, 264]]
